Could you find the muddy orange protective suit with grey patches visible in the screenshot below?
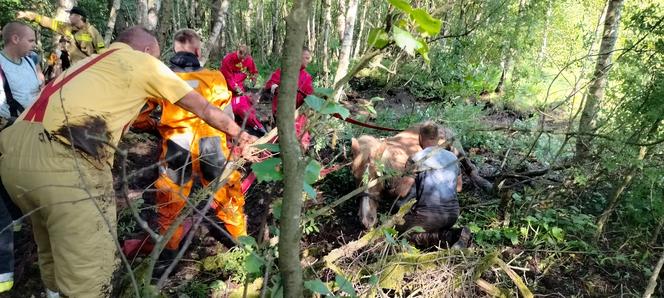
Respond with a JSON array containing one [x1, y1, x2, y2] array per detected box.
[[147, 70, 247, 249]]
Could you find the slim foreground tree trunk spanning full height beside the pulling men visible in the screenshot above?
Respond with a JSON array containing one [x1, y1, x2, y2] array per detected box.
[[277, 0, 311, 297]]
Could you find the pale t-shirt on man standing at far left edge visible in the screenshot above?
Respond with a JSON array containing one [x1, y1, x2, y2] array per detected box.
[[0, 52, 40, 118]]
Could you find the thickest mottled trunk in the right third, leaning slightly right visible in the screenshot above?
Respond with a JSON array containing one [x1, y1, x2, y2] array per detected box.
[[575, 0, 623, 160]]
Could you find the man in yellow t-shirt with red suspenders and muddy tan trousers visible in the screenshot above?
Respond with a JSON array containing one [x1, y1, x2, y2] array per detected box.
[[0, 27, 255, 297]]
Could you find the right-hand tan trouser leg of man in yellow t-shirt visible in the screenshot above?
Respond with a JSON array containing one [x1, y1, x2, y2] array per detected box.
[[43, 165, 118, 297]]
